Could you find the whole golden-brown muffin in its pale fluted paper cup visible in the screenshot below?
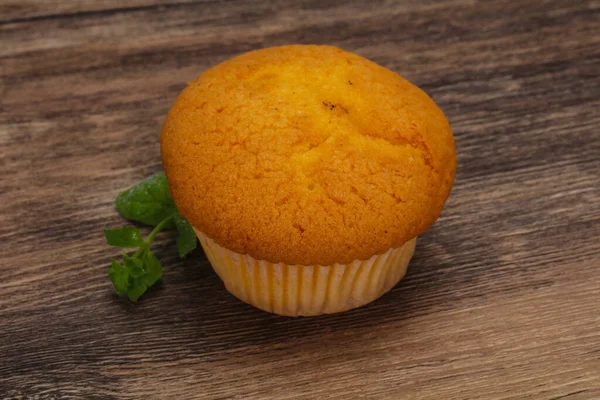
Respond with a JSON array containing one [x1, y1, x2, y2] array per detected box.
[[161, 45, 456, 316]]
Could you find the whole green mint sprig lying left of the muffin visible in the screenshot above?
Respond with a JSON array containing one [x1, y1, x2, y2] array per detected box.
[[104, 172, 198, 302]]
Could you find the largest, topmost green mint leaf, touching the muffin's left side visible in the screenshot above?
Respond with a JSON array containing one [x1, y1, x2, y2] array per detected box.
[[116, 172, 177, 227]]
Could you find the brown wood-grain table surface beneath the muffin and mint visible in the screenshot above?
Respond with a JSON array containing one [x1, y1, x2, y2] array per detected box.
[[0, 0, 600, 400]]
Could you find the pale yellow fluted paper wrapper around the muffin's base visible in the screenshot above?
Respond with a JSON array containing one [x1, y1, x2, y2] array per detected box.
[[196, 230, 417, 316]]
